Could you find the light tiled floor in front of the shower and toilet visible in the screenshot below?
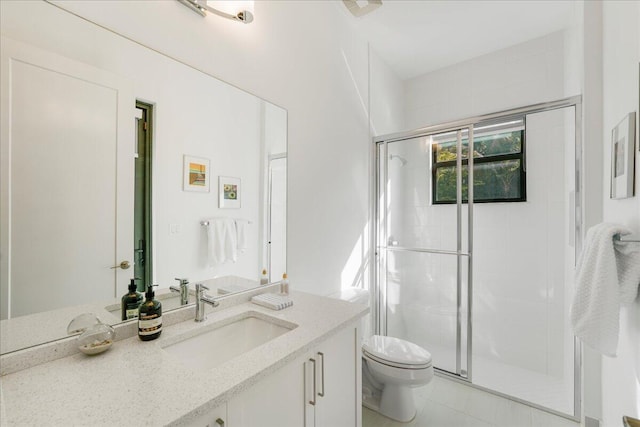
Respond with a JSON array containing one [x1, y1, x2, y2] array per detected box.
[[362, 377, 580, 427]]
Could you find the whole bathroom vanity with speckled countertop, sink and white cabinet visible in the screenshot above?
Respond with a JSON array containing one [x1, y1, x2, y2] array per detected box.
[[0, 292, 368, 427]]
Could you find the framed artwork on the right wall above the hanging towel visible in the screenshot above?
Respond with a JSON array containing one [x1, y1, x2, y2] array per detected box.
[[611, 112, 636, 199]]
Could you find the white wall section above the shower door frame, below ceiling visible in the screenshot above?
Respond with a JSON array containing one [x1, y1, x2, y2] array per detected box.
[[404, 31, 577, 129]]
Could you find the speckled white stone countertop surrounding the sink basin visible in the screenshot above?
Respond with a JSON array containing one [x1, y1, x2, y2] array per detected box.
[[0, 292, 368, 426]]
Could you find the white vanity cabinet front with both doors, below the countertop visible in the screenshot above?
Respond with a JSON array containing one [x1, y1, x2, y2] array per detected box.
[[225, 325, 361, 427]]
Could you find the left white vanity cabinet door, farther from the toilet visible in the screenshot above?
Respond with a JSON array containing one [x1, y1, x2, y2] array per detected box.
[[228, 358, 306, 427]]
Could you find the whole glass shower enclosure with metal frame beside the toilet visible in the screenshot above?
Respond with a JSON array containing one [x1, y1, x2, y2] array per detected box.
[[374, 97, 581, 419]]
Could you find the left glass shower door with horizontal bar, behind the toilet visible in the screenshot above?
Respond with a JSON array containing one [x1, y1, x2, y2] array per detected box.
[[377, 129, 473, 378]]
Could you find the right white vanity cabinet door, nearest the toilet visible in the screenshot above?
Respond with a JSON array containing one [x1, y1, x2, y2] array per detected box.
[[314, 327, 361, 427]]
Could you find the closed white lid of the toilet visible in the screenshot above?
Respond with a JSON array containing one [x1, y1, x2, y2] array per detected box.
[[362, 335, 431, 368]]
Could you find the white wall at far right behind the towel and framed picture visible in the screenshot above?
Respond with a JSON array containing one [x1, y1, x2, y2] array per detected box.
[[602, 1, 640, 427]]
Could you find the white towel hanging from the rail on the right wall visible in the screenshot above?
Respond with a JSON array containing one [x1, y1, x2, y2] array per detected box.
[[571, 223, 640, 356]]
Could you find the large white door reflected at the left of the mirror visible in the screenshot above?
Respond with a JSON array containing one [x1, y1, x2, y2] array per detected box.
[[1, 38, 135, 319]]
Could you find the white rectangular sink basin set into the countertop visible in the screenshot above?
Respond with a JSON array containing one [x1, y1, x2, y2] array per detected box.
[[164, 313, 297, 369]]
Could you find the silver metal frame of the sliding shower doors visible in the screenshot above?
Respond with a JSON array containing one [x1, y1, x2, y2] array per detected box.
[[371, 95, 584, 422]]
